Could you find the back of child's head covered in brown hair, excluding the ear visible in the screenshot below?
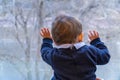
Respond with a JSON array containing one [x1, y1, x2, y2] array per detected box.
[[51, 15, 82, 45]]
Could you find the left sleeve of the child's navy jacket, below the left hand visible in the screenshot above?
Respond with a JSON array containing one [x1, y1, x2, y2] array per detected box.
[[40, 38, 53, 65]]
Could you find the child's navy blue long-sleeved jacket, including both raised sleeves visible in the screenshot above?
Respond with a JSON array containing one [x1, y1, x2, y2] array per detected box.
[[41, 38, 110, 80]]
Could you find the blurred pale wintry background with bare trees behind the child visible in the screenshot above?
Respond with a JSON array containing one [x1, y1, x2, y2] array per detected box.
[[0, 0, 120, 80]]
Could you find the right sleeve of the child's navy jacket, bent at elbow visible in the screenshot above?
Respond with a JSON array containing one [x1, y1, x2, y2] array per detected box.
[[90, 38, 110, 65]]
